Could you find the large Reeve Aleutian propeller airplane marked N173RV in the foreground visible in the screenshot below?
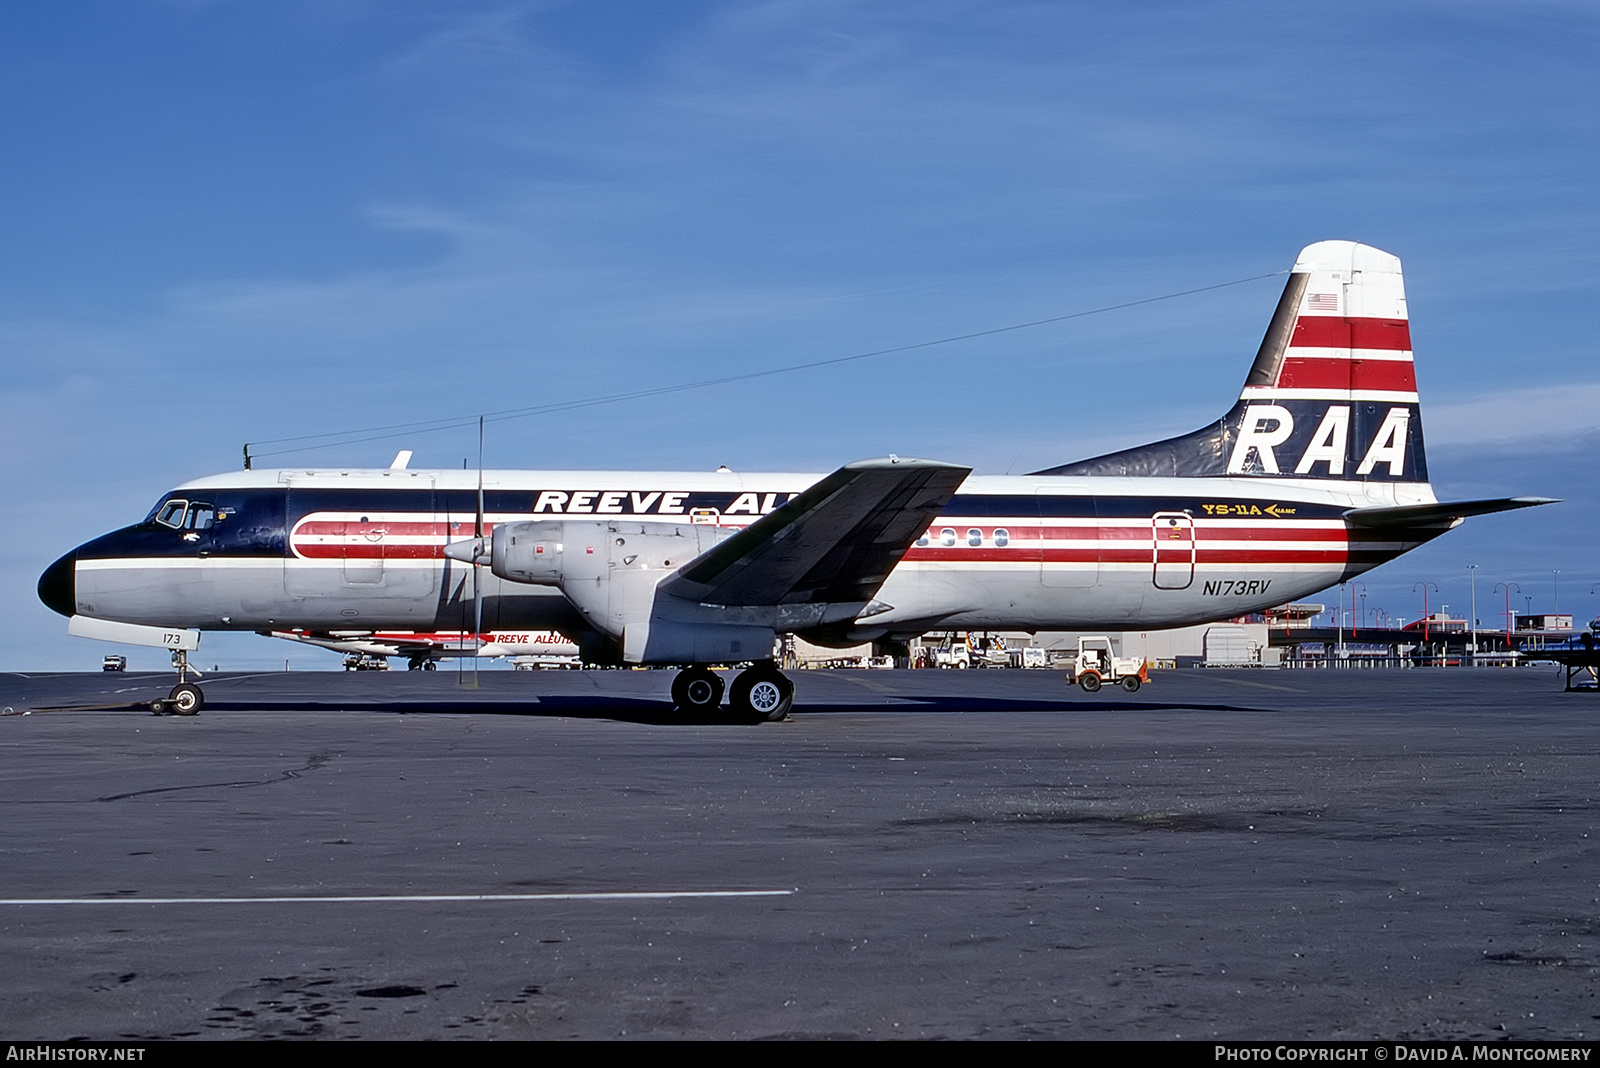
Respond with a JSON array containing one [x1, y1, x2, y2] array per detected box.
[[38, 241, 1547, 719]]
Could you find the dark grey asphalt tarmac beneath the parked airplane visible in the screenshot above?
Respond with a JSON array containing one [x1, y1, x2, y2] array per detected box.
[[0, 668, 1600, 1039]]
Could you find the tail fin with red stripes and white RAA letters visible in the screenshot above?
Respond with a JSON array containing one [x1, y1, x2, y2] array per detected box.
[[1034, 241, 1427, 483]]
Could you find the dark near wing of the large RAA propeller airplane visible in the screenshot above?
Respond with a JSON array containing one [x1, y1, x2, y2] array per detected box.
[[659, 456, 971, 606]]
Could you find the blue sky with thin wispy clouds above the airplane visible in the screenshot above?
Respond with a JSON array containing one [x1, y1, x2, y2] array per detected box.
[[0, 0, 1600, 670]]
